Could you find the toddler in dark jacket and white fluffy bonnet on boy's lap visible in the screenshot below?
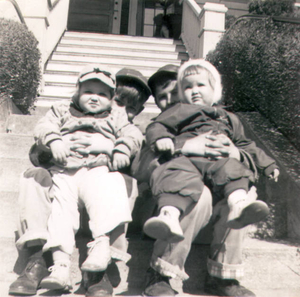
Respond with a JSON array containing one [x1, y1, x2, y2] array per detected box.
[[144, 59, 279, 242]]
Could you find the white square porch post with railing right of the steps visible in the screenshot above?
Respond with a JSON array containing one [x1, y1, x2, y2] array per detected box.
[[181, 0, 227, 59]]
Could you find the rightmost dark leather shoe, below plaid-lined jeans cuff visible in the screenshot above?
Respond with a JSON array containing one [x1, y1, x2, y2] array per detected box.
[[204, 274, 255, 297]]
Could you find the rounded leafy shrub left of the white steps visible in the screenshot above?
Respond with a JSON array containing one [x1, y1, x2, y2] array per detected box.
[[0, 18, 41, 114]]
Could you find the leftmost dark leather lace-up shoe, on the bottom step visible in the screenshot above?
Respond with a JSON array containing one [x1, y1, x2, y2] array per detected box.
[[8, 257, 49, 295]]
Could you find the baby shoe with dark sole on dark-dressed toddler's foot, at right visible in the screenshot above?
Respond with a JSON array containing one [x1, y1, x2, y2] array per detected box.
[[227, 191, 270, 229]]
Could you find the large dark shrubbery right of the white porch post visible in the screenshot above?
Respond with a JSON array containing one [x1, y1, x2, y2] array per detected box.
[[207, 0, 300, 148]]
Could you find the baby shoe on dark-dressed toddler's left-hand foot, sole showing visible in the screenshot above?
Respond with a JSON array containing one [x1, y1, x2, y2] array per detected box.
[[143, 207, 184, 243]]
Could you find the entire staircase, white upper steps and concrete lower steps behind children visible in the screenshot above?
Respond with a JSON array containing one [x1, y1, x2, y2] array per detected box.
[[0, 32, 300, 297]]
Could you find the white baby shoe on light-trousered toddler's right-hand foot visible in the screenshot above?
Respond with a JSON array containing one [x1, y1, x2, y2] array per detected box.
[[81, 236, 111, 272]]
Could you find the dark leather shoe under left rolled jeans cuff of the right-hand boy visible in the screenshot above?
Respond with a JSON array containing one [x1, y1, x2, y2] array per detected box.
[[142, 267, 178, 296]]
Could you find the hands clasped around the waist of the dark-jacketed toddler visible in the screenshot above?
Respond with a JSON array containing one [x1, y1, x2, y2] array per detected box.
[[181, 131, 240, 160]]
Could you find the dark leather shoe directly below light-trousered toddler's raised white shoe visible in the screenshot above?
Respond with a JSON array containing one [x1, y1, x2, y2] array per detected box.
[[85, 271, 113, 297]]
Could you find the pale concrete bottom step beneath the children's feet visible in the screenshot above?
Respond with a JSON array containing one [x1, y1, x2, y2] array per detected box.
[[0, 235, 300, 297]]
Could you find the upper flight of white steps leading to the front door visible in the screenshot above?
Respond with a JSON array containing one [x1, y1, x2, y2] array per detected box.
[[33, 31, 188, 114]]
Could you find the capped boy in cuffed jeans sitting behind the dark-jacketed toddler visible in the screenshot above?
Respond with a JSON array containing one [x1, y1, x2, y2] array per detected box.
[[131, 64, 278, 296]]
